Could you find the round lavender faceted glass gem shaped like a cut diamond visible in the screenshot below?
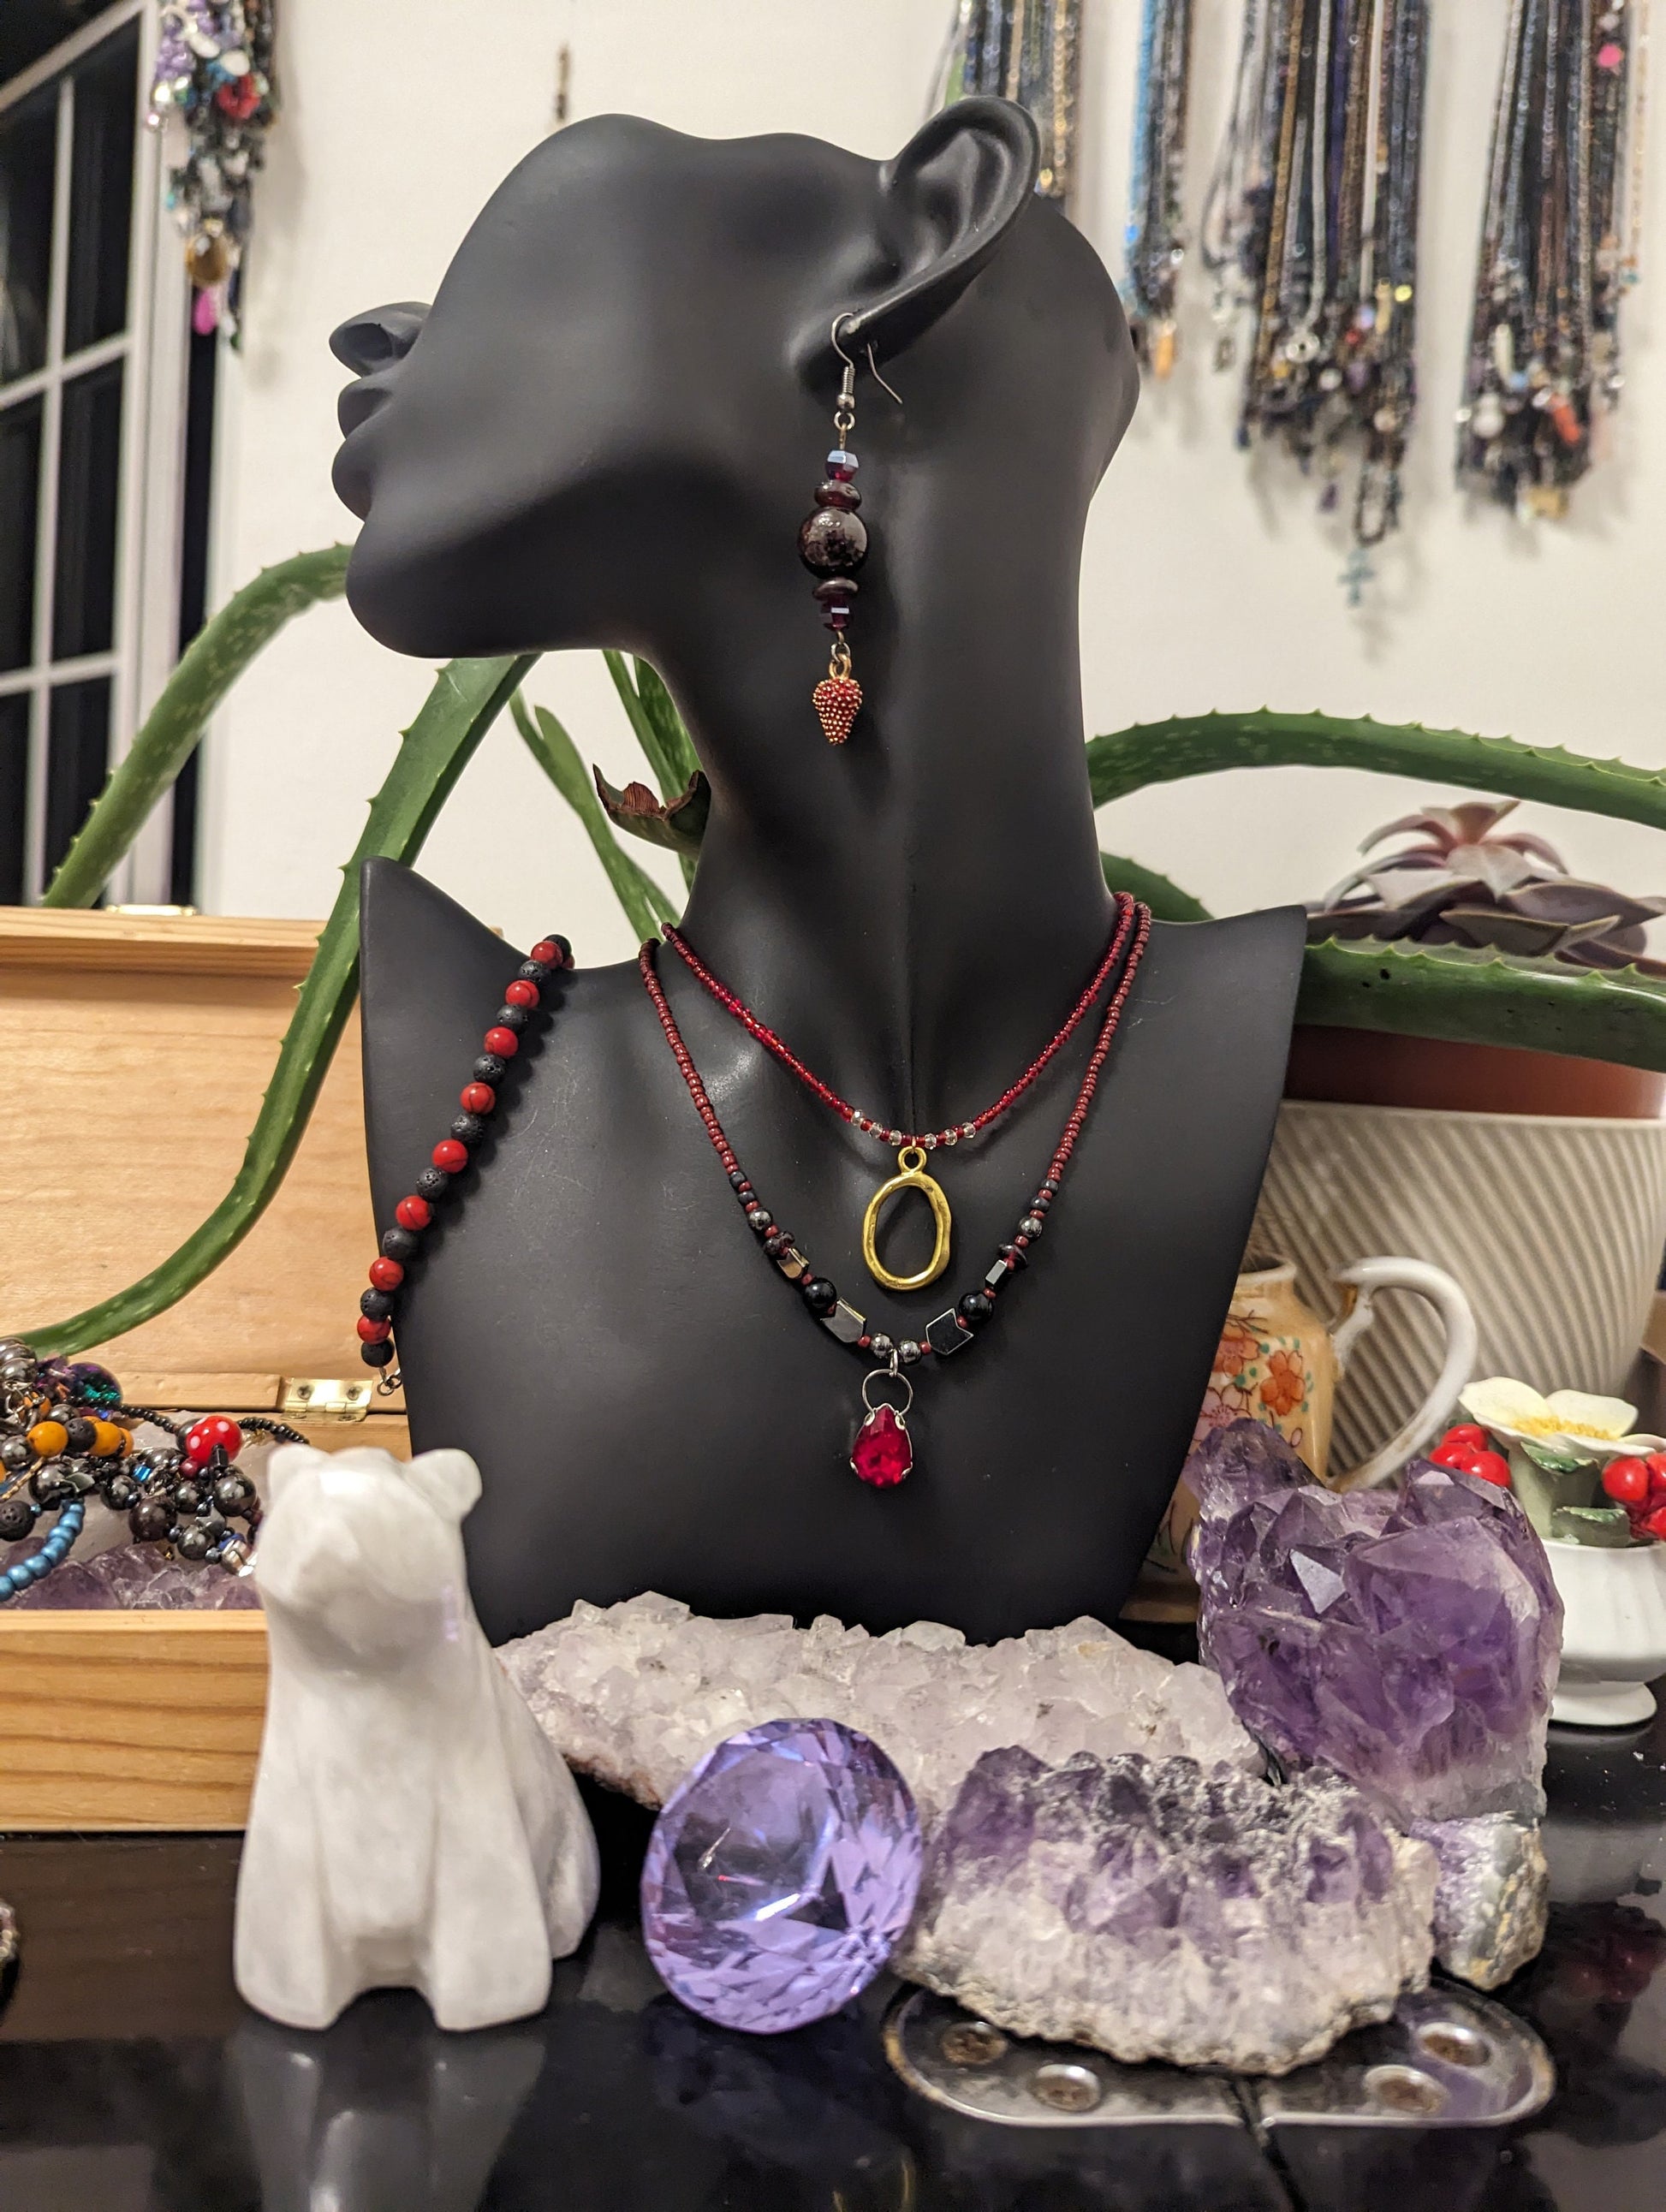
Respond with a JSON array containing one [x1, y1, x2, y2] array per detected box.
[[641, 1721, 920, 2035]]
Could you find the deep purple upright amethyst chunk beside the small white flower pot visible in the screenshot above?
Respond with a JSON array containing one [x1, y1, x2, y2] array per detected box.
[[1186, 1420, 1562, 1821]]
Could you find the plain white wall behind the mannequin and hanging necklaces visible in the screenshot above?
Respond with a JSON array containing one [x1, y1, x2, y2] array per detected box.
[[201, 0, 1666, 960]]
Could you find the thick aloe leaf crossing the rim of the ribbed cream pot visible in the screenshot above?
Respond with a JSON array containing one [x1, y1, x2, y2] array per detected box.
[[1296, 938, 1666, 1073]]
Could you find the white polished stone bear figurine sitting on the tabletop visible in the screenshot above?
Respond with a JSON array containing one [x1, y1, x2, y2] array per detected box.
[[235, 1444, 599, 2029]]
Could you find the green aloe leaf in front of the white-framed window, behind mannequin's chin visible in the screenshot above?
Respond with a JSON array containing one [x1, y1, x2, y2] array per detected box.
[[42, 546, 352, 907]]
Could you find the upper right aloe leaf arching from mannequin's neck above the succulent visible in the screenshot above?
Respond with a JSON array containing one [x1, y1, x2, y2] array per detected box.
[[1086, 708, 1666, 830]]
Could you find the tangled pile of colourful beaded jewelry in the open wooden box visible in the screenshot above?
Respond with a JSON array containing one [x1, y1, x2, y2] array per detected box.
[[0, 1341, 303, 1602]]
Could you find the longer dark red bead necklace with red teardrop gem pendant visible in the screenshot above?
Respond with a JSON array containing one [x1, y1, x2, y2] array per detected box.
[[637, 898, 1151, 1489]]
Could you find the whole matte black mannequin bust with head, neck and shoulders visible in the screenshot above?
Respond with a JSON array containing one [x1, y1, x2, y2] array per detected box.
[[332, 99, 1303, 1639]]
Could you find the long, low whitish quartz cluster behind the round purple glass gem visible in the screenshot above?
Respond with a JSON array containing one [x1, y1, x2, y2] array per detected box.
[[497, 1595, 1261, 1829]]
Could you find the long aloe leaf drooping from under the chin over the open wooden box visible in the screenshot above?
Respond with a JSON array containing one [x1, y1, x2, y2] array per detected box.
[[14, 655, 535, 1352]]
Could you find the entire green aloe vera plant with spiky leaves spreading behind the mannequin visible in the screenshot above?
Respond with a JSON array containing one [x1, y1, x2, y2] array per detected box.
[[27, 546, 1666, 1352]]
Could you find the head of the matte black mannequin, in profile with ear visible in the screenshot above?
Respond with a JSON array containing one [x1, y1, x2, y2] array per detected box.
[[332, 99, 1137, 668]]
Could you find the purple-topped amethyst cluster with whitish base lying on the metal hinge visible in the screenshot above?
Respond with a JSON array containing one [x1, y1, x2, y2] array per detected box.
[[896, 1750, 1436, 2072]]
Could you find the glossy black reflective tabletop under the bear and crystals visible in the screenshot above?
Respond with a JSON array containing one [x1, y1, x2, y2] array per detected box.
[[0, 1690, 1666, 2212]]
